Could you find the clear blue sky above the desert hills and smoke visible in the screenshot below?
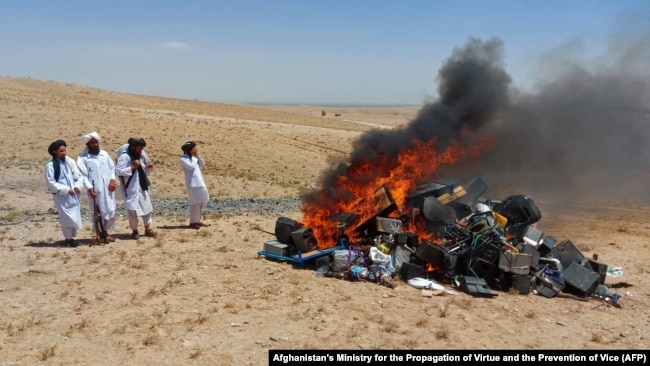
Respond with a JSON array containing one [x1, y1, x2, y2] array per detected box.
[[0, 0, 650, 105]]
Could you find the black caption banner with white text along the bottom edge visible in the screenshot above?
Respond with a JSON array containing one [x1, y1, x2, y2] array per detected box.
[[269, 350, 646, 366]]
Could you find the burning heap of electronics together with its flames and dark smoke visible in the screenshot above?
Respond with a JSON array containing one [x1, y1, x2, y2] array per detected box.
[[260, 38, 650, 303]]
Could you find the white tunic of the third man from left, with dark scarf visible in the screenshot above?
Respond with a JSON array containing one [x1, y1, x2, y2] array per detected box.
[[115, 152, 153, 216]]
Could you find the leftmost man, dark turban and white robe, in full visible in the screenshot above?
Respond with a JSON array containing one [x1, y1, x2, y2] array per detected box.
[[45, 140, 83, 247]]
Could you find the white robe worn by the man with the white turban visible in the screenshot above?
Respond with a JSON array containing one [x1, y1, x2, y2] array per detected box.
[[77, 149, 116, 220]]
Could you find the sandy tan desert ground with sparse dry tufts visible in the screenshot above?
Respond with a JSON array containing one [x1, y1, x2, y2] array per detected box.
[[0, 77, 650, 365]]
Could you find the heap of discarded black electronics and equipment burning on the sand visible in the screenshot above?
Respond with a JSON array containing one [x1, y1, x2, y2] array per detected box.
[[260, 178, 618, 304]]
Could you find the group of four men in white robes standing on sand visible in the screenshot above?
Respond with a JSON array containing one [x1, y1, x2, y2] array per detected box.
[[45, 132, 209, 247]]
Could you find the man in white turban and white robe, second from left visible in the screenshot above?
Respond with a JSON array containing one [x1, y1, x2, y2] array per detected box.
[[77, 132, 116, 243]]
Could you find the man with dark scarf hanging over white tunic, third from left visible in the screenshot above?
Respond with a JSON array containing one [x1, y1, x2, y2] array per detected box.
[[115, 138, 156, 239]]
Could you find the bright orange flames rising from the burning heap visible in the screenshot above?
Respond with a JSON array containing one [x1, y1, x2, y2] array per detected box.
[[302, 137, 489, 249]]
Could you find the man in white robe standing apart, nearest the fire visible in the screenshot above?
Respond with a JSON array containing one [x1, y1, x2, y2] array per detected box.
[[180, 141, 210, 229]]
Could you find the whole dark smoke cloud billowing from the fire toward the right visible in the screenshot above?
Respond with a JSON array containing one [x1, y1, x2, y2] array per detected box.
[[303, 33, 650, 214]]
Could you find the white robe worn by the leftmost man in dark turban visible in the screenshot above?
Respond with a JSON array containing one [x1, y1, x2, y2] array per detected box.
[[45, 156, 83, 229]]
